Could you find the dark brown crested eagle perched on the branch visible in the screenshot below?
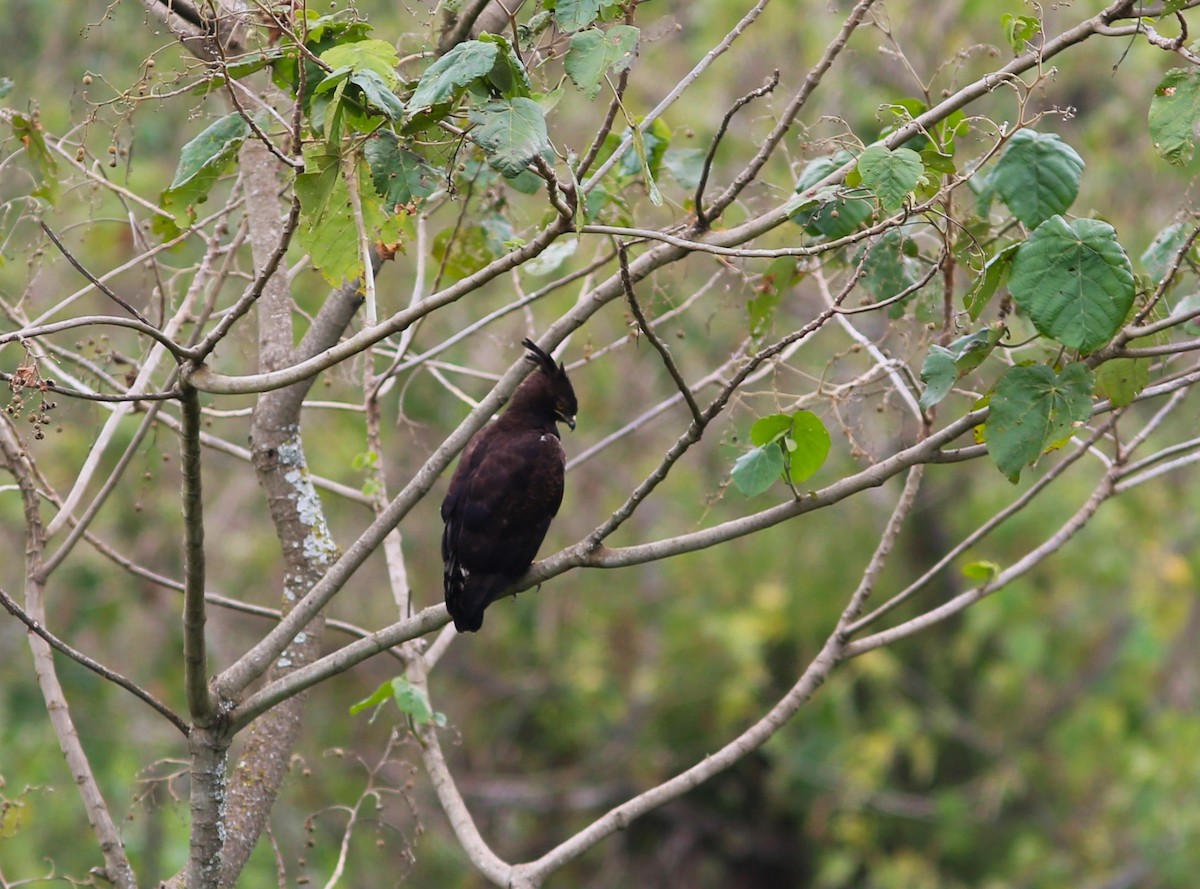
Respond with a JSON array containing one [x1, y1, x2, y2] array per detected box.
[[442, 340, 578, 632]]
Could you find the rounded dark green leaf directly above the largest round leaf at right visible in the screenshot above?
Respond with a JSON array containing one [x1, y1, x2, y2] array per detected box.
[[989, 130, 1084, 228]]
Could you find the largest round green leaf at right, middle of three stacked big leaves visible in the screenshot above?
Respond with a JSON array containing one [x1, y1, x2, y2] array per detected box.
[[1008, 216, 1134, 355]]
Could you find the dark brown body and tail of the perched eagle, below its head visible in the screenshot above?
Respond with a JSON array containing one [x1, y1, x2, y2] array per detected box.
[[442, 418, 565, 629]]
